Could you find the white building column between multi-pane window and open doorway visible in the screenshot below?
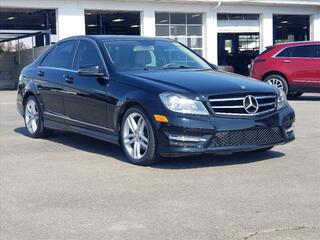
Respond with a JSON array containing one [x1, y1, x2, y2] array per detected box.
[[204, 8, 218, 64]]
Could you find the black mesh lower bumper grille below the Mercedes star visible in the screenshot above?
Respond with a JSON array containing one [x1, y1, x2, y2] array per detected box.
[[209, 128, 283, 148]]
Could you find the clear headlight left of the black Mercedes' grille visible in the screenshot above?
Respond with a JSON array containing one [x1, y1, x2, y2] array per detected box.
[[159, 93, 209, 115]]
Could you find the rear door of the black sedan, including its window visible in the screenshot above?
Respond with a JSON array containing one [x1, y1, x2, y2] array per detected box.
[[36, 40, 76, 120]]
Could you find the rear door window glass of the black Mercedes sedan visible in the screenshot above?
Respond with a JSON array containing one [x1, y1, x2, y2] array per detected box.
[[49, 40, 76, 69]]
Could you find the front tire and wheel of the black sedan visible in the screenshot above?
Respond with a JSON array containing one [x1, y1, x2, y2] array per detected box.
[[120, 106, 160, 166]]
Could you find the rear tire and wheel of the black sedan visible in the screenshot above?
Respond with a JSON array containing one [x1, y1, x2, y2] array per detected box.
[[24, 96, 52, 138]]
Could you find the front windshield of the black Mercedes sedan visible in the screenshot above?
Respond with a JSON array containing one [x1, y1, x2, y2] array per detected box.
[[104, 40, 211, 71]]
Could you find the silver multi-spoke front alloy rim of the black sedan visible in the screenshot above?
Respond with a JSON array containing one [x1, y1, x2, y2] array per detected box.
[[122, 112, 149, 159]]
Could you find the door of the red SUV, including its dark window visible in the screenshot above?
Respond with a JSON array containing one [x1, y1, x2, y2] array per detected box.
[[284, 44, 319, 87]]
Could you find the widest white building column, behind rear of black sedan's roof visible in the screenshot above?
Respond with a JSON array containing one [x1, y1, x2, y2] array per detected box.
[[56, 6, 86, 40]]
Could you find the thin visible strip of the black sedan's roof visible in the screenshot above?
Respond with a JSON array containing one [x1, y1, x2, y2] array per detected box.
[[58, 35, 173, 43]]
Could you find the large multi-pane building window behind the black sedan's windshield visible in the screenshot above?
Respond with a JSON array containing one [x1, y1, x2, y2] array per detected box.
[[156, 12, 203, 55]]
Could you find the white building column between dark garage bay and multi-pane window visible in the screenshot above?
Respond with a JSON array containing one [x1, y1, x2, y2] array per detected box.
[[140, 9, 156, 37]]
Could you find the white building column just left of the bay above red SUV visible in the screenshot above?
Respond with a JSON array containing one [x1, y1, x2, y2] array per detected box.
[[260, 13, 273, 52]]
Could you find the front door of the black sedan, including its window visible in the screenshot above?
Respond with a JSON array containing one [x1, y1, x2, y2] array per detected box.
[[63, 39, 108, 130]]
